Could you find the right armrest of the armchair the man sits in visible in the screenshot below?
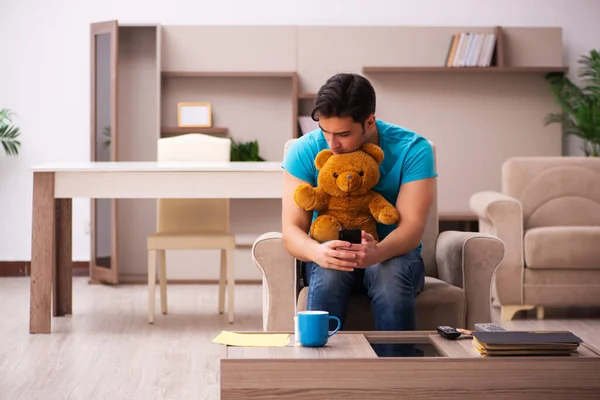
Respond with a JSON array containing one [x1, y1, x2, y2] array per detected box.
[[435, 231, 504, 329]]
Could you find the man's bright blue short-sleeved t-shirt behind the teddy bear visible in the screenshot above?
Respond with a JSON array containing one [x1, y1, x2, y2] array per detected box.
[[283, 120, 438, 250]]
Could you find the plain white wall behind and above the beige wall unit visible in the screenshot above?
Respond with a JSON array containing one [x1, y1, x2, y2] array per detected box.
[[0, 0, 600, 261]]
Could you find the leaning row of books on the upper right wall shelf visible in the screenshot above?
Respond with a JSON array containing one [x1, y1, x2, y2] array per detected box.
[[446, 32, 496, 67]]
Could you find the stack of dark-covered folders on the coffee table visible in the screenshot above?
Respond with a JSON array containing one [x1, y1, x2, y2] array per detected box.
[[473, 332, 582, 357]]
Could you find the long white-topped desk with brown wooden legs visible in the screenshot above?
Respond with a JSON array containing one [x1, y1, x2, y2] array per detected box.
[[29, 162, 283, 333]]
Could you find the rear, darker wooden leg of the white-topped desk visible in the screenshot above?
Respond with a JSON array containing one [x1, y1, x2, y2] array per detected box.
[[53, 199, 73, 316]]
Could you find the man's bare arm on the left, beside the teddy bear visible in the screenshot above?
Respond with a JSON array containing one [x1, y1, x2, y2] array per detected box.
[[281, 171, 319, 261]]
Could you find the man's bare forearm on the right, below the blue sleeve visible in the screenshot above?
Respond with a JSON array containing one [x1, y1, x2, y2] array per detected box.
[[376, 178, 435, 262]]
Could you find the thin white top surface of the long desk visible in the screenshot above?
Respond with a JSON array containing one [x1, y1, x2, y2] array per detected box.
[[31, 161, 283, 172]]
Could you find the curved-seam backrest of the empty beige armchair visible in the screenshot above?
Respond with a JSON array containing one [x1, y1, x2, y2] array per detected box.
[[502, 157, 600, 230]]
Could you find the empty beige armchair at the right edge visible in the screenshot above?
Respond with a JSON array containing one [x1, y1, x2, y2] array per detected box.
[[471, 157, 600, 320]]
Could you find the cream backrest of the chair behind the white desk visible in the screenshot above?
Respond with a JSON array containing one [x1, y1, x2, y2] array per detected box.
[[157, 133, 231, 233]]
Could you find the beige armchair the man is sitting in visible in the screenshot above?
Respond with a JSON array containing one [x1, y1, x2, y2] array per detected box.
[[252, 140, 504, 331]]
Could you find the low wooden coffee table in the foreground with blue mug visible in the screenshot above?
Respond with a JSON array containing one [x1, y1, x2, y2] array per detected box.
[[220, 332, 600, 400]]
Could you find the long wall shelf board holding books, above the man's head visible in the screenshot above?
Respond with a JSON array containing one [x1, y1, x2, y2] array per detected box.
[[362, 67, 569, 74]]
